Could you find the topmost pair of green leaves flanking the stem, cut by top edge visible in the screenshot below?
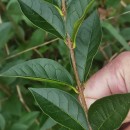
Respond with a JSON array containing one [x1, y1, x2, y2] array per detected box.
[[19, 0, 94, 44]]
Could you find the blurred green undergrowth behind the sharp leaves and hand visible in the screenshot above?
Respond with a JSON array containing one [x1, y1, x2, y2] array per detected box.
[[0, 0, 130, 130]]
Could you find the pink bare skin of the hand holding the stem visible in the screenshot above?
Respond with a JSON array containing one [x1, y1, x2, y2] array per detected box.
[[84, 52, 130, 130]]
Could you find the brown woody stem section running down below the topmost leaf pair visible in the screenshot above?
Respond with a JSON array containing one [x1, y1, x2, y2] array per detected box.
[[66, 36, 91, 130]]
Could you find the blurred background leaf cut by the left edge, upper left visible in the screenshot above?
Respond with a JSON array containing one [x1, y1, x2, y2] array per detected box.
[[0, 22, 14, 48]]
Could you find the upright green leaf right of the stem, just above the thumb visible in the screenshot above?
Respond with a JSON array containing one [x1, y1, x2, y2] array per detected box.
[[75, 11, 102, 82]]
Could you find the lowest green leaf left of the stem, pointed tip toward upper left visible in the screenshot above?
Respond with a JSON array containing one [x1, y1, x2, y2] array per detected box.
[[30, 88, 88, 130]]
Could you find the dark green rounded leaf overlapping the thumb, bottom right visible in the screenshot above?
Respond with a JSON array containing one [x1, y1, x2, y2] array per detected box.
[[88, 94, 130, 130]]
